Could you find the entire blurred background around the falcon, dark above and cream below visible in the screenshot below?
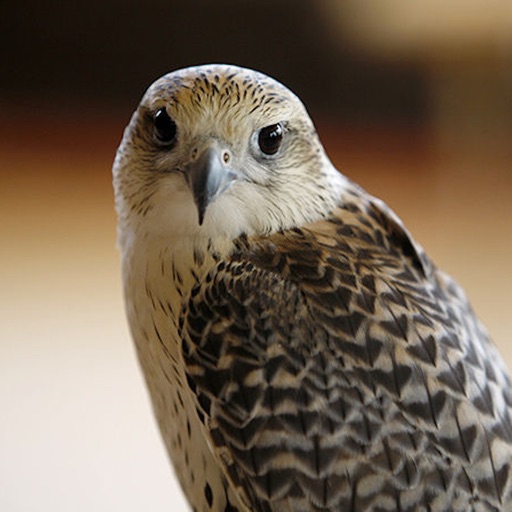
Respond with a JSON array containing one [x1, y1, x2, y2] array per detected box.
[[0, 0, 512, 512]]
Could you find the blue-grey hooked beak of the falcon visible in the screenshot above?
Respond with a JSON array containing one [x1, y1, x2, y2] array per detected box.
[[186, 146, 236, 226]]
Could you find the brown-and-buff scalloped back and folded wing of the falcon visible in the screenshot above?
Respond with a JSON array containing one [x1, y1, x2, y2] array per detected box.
[[182, 194, 512, 511]]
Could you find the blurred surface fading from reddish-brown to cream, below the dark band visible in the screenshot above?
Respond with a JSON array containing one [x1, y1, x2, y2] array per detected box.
[[0, 111, 512, 511]]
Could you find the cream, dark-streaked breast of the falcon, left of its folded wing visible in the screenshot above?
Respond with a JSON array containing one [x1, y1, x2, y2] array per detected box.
[[124, 247, 240, 510]]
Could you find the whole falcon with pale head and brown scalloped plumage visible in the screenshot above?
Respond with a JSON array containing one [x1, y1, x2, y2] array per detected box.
[[113, 64, 512, 512]]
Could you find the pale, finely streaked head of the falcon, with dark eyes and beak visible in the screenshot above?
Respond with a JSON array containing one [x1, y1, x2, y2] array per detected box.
[[114, 65, 342, 248]]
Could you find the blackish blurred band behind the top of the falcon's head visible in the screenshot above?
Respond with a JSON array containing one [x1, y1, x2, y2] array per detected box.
[[0, 0, 427, 123]]
